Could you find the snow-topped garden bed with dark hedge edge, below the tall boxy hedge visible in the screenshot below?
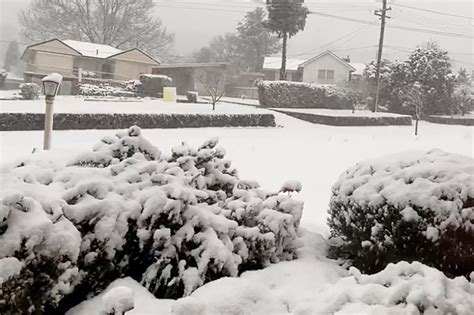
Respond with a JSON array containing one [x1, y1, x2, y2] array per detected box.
[[272, 108, 412, 126]]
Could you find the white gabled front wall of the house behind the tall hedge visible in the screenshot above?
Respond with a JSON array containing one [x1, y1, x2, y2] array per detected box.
[[303, 54, 350, 83]]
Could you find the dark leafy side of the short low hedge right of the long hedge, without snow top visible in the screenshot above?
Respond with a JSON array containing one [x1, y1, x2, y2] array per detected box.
[[276, 110, 411, 126]]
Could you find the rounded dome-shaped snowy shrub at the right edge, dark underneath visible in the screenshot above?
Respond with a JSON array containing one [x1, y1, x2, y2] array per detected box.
[[328, 150, 474, 277]]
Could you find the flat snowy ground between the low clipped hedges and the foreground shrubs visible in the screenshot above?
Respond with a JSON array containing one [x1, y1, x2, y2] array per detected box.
[[0, 111, 474, 235]]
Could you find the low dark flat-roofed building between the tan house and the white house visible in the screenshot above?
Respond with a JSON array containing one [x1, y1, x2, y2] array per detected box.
[[152, 63, 227, 95]]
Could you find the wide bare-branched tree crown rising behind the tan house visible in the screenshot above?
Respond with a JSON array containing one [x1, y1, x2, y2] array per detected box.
[[19, 0, 174, 55]]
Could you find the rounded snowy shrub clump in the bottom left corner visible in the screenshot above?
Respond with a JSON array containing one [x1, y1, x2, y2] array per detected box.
[[0, 194, 81, 314]]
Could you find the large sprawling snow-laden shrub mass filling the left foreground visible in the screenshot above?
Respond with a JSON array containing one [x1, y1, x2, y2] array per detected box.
[[0, 127, 303, 314]]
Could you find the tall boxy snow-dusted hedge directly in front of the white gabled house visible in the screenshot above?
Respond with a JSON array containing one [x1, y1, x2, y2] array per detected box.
[[258, 81, 357, 109]]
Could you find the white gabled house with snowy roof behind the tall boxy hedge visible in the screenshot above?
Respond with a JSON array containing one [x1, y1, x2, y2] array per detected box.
[[263, 50, 365, 84]]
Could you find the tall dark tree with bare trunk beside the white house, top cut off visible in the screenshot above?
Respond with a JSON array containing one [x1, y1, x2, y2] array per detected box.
[[265, 0, 309, 80]]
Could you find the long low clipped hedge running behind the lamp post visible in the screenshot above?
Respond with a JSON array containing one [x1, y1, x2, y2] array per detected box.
[[0, 113, 275, 131]]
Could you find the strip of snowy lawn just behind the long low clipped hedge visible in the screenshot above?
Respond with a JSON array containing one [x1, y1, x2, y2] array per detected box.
[[0, 96, 270, 115]]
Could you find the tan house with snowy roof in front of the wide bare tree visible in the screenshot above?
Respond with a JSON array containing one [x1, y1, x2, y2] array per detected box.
[[21, 38, 160, 94]]
